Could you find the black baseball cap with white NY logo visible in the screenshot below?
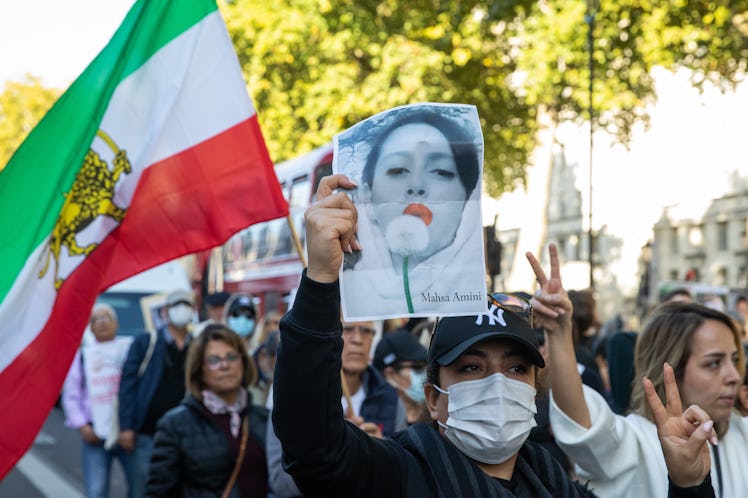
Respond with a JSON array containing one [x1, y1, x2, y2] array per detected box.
[[428, 305, 545, 368]]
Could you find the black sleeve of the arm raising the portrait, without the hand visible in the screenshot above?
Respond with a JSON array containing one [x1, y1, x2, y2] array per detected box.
[[272, 273, 406, 498]]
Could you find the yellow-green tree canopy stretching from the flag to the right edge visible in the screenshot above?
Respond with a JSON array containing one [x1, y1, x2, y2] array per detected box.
[[222, 0, 748, 195]]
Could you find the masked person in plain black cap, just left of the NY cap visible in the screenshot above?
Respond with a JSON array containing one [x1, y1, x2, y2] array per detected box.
[[372, 329, 428, 425]]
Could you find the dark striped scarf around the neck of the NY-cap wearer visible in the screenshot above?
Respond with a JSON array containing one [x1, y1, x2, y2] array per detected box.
[[394, 423, 594, 498]]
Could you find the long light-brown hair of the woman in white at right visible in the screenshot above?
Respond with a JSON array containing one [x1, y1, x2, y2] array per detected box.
[[631, 301, 745, 436]]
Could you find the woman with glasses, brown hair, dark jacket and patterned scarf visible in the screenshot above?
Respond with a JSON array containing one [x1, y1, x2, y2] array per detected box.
[[147, 324, 268, 498]]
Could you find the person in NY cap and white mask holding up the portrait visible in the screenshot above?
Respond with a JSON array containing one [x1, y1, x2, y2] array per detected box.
[[273, 175, 720, 498]]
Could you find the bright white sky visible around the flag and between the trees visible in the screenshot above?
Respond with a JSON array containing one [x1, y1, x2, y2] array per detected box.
[[5, 0, 748, 300]]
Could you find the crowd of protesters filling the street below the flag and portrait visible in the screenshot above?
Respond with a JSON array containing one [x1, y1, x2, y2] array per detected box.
[[62, 185, 748, 498]]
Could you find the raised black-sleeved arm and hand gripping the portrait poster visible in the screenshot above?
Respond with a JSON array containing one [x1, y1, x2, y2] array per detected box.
[[272, 175, 404, 498]]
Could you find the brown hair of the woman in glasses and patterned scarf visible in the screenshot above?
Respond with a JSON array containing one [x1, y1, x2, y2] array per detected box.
[[184, 323, 257, 401]]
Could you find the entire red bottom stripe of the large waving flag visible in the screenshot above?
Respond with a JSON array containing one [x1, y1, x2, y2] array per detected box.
[[0, 116, 288, 479]]
